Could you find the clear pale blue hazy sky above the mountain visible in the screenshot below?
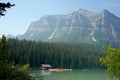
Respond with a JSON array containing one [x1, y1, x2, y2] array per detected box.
[[0, 0, 120, 36]]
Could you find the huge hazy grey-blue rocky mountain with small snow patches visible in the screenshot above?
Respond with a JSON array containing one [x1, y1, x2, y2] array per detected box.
[[19, 9, 120, 43]]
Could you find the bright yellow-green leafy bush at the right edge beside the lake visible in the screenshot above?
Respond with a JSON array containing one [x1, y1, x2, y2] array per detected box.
[[100, 44, 120, 80]]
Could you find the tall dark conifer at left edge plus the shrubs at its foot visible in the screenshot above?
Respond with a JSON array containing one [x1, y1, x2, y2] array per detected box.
[[0, 36, 29, 80]]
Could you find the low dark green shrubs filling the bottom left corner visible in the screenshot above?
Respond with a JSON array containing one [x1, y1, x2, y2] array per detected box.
[[0, 63, 28, 80]]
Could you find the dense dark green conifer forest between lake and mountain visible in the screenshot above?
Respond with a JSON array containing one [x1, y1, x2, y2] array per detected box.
[[7, 39, 104, 68]]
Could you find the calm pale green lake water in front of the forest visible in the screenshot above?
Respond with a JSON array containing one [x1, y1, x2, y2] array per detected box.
[[31, 69, 117, 80]]
